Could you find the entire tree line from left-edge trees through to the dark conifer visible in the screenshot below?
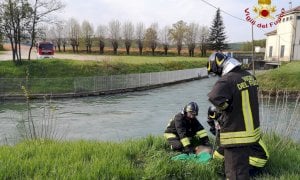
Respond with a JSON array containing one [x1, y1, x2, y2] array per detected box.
[[0, 0, 228, 63]]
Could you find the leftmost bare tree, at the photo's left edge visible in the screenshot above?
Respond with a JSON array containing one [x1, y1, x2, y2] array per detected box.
[[0, 0, 33, 64]]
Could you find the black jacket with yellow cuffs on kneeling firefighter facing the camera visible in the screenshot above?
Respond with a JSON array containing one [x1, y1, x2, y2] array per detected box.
[[164, 113, 209, 147]]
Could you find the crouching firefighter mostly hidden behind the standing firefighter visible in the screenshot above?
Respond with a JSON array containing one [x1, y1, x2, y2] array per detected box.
[[207, 106, 269, 175]]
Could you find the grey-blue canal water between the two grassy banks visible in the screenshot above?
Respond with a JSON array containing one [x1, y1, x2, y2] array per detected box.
[[0, 77, 300, 144]]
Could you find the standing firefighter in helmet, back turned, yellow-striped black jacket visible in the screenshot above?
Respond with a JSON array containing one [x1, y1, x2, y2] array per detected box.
[[207, 52, 261, 180]]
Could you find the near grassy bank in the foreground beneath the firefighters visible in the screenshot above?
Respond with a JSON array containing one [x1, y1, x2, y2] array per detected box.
[[0, 135, 300, 179]]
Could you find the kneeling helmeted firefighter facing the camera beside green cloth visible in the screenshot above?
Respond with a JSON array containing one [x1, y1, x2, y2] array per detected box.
[[164, 102, 209, 153]]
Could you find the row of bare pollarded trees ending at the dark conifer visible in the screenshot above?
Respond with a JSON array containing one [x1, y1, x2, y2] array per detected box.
[[44, 9, 228, 57]]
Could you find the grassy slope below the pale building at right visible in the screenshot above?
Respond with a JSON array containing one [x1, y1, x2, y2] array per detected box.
[[257, 61, 300, 91]]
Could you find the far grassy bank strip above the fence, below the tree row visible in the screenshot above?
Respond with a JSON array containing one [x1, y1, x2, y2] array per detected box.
[[0, 56, 206, 78]]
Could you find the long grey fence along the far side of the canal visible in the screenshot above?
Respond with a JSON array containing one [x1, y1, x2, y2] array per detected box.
[[0, 68, 207, 98]]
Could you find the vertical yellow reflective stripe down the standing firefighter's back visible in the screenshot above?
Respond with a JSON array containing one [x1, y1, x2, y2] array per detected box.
[[242, 90, 254, 131]]
